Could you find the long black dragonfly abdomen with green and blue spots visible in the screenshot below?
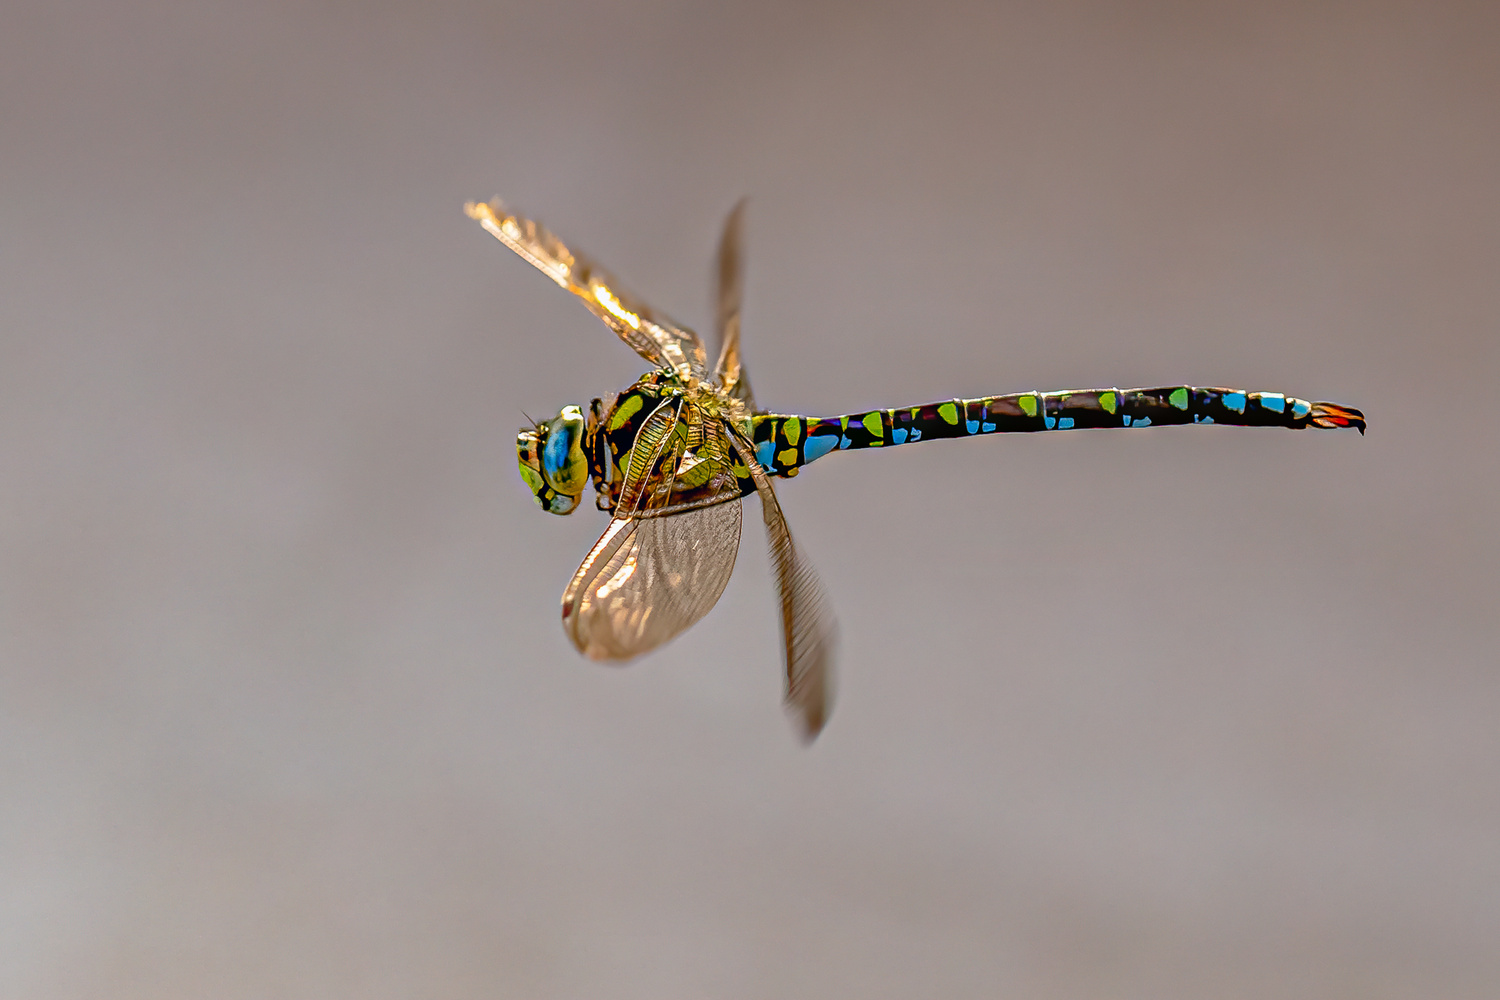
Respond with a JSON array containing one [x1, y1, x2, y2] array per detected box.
[[753, 385, 1365, 475]]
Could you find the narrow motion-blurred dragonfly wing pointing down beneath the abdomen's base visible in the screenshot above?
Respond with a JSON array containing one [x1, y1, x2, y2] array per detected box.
[[735, 432, 836, 742]]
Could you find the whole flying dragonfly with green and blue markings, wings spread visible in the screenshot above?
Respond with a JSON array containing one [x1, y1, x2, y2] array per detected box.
[[465, 199, 1365, 741]]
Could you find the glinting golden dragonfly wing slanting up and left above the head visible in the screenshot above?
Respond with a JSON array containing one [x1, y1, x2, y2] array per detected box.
[[464, 199, 708, 378]]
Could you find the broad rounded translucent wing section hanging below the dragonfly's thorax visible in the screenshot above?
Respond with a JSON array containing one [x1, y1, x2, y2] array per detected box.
[[563, 501, 743, 660]]
